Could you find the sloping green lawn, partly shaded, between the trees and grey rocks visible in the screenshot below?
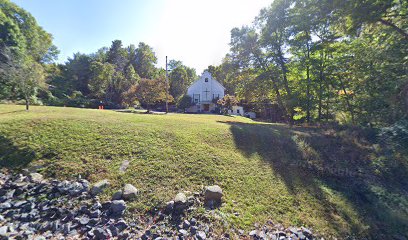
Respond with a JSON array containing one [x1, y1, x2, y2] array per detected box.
[[0, 105, 408, 237]]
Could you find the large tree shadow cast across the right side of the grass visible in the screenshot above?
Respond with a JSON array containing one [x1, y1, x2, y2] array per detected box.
[[218, 121, 408, 238]]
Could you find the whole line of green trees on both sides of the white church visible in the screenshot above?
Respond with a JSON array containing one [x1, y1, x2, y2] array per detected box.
[[0, 0, 408, 127]]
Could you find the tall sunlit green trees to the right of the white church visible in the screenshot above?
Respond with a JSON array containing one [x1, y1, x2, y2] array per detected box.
[[209, 0, 408, 126]]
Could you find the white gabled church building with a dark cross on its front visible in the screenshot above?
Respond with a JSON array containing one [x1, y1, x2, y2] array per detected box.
[[187, 71, 225, 112]]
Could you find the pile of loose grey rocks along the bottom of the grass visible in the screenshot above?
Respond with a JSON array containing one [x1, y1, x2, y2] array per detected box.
[[0, 170, 313, 240]]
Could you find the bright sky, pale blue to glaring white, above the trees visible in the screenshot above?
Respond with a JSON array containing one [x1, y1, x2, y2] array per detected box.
[[12, 0, 272, 73]]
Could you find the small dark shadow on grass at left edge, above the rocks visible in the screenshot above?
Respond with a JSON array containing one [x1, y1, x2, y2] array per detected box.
[[0, 135, 36, 169]]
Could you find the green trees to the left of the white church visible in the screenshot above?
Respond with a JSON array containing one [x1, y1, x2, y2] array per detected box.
[[0, 0, 197, 109]]
